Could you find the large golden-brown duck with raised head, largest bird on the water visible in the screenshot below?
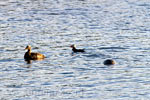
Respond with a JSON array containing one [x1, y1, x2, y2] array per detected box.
[[24, 45, 45, 60]]
